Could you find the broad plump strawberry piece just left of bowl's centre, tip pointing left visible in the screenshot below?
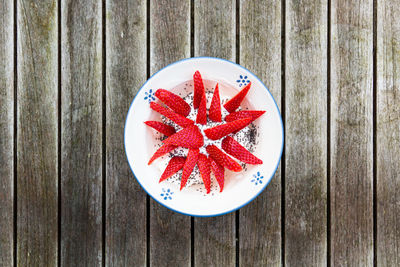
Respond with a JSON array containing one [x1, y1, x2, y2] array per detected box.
[[163, 125, 204, 148]]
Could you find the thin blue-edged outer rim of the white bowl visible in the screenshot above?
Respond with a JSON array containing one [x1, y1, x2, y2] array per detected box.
[[124, 56, 285, 217]]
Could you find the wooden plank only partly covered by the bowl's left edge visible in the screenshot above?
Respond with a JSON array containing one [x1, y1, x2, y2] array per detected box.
[[105, 0, 147, 266]]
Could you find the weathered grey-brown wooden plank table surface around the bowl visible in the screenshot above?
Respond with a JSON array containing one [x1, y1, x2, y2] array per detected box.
[[0, 0, 400, 266]]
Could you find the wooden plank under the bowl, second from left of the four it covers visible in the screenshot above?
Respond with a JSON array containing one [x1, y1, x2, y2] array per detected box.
[[149, 0, 191, 266]]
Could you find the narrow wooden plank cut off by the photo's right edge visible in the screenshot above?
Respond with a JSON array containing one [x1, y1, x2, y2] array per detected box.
[[376, 0, 400, 266]]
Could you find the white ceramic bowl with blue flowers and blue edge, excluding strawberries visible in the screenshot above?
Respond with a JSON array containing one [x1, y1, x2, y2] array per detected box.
[[125, 57, 284, 216]]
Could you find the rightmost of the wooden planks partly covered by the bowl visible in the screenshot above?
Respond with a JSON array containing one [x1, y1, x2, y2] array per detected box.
[[239, 0, 282, 266]]
